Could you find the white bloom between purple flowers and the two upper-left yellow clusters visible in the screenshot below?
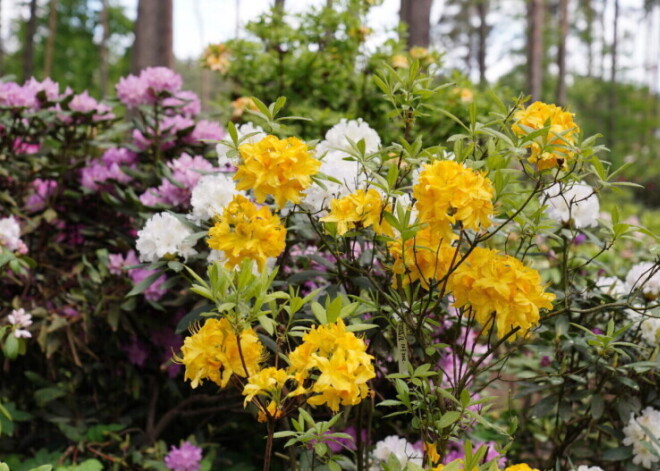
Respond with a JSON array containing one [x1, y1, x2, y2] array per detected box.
[[188, 174, 242, 224]]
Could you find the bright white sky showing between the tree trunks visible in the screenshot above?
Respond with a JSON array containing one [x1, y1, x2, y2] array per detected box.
[[1, 0, 660, 91]]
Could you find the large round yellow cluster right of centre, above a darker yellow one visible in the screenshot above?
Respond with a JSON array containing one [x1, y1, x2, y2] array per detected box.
[[413, 160, 495, 242]]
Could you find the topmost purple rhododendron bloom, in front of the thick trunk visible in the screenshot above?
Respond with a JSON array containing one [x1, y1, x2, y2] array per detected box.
[[117, 67, 183, 110]]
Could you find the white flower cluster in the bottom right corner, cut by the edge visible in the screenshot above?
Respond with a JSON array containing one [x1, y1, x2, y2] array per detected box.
[[623, 407, 660, 469]]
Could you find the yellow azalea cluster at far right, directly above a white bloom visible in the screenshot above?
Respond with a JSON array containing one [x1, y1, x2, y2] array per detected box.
[[511, 101, 580, 170]]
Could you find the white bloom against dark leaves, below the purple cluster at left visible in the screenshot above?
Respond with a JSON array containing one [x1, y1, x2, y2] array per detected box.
[[135, 213, 197, 262]]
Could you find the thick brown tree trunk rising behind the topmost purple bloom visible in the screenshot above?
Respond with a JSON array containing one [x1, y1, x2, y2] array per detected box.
[[132, 0, 174, 73]]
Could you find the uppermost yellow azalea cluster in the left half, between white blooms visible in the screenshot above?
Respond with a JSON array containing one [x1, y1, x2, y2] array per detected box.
[[234, 136, 321, 208]]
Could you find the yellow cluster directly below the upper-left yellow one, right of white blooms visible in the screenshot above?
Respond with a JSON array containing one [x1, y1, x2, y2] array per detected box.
[[208, 195, 286, 271]]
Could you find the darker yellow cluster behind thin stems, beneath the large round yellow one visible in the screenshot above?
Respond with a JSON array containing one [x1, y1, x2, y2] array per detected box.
[[387, 227, 460, 289]]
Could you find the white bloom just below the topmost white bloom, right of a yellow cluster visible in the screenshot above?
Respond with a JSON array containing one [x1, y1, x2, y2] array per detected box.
[[301, 152, 366, 216]]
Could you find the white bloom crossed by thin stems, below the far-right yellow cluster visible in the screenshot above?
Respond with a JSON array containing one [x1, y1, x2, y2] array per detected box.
[[541, 182, 600, 229]]
